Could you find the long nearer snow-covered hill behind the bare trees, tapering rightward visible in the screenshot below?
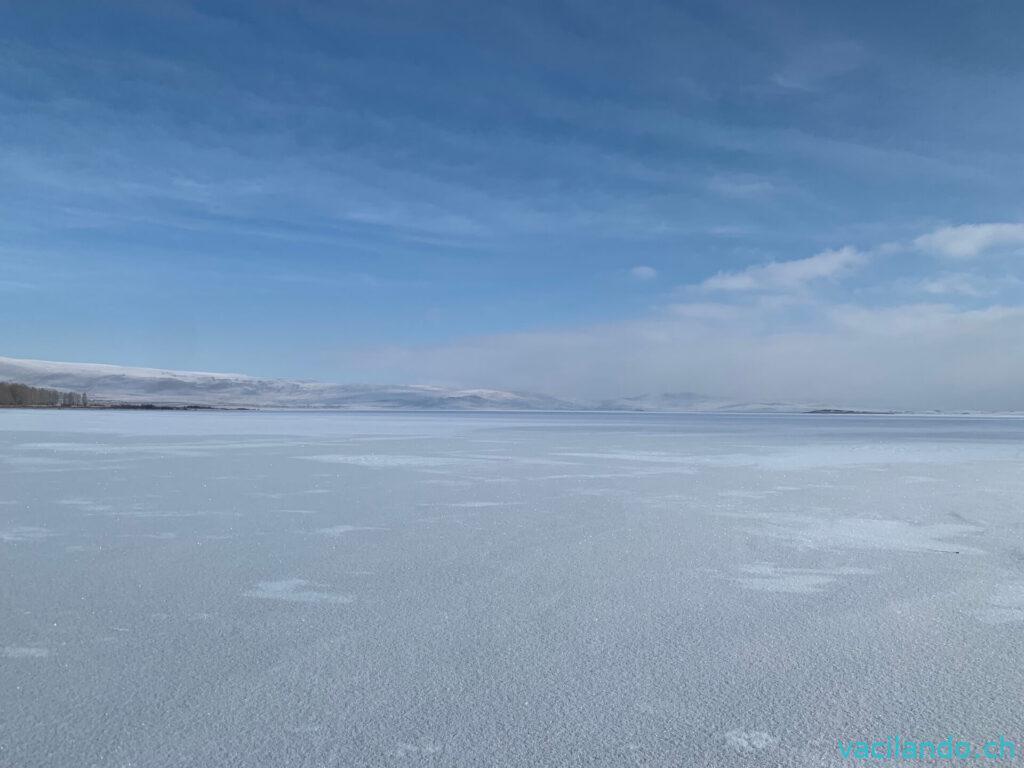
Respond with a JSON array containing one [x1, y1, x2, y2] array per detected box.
[[0, 357, 574, 411]]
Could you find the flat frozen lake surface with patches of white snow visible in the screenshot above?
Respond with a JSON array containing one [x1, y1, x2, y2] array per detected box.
[[0, 411, 1024, 768]]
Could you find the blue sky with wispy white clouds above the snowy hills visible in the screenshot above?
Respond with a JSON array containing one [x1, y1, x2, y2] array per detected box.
[[0, 0, 1024, 408]]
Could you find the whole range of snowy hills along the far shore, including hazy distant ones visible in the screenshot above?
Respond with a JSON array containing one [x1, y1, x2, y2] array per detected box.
[[0, 356, 827, 414]]
